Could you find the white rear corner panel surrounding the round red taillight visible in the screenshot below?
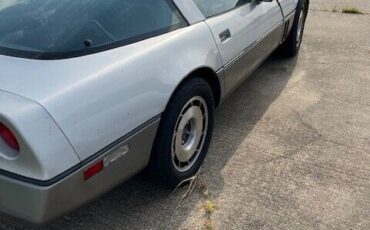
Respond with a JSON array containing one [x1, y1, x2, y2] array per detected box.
[[0, 90, 80, 180]]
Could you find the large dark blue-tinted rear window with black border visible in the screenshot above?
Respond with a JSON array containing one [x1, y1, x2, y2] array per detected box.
[[0, 0, 185, 58]]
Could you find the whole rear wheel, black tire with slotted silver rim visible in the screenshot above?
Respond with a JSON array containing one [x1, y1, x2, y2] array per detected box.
[[152, 78, 214, 188]]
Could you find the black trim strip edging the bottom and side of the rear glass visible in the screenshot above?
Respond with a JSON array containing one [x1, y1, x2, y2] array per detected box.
[[0, 0, 189, 60]]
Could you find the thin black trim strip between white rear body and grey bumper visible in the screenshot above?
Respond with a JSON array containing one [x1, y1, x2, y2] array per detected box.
[[0, 114, 161, 187]]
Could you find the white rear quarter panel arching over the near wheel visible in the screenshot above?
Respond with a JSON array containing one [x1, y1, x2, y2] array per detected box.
[[0, 22, 222, 160]]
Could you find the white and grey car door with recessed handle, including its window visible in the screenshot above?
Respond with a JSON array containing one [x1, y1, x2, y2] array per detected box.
[[194, 0, 284, 93]]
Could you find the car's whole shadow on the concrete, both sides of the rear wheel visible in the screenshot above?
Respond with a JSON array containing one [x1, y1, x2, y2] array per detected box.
[[0, 54, 297, 230]]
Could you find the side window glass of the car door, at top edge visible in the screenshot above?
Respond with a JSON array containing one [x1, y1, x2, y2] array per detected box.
[[193, 0, 253, 18]]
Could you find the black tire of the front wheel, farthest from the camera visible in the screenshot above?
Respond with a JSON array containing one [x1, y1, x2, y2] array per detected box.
[[279, 0, 308, 57]]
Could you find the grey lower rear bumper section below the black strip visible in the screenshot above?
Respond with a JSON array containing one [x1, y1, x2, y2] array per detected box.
[[0, 118, 159, 223]]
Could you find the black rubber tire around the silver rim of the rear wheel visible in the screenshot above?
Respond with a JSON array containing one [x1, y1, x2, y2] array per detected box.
[[151, 77, 214, 189]]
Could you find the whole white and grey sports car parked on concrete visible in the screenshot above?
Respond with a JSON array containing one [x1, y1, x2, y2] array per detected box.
[[0, 0, 309, 223]]
